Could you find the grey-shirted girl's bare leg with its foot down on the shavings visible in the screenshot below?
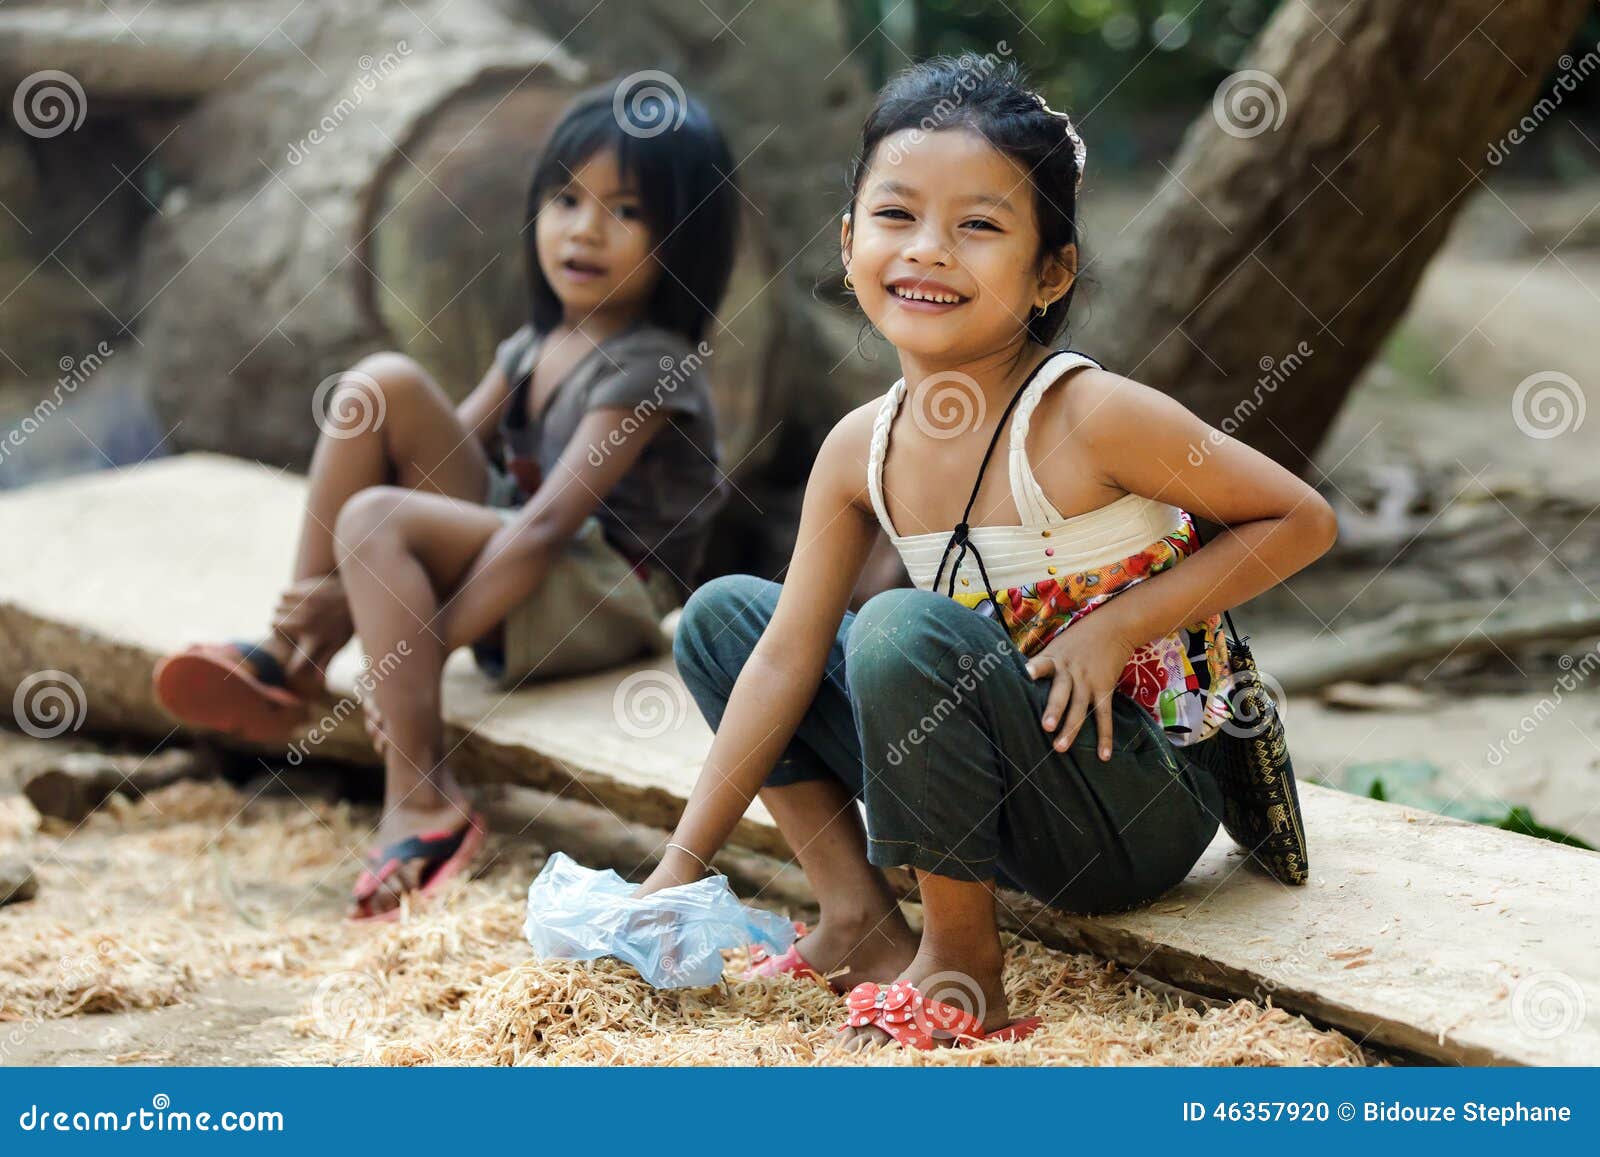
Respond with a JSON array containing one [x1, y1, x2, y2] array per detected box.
[[334, 486, 504, 911]]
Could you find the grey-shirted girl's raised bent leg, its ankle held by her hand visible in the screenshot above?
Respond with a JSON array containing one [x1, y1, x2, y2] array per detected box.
[[264, 354, 488, 693]]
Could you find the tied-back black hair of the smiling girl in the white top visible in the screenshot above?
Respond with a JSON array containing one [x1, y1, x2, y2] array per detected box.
[[850, 53, 1078, 346]]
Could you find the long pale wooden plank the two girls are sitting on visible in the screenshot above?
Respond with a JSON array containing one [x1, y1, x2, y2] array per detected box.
[[0, 454, 1600, 1064]]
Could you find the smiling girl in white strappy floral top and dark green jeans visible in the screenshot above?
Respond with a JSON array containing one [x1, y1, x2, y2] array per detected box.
[[642, 59, 1336, 1047]]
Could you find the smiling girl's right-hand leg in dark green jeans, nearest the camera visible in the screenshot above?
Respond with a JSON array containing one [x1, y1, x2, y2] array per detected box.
[[846, 591, 1221, 1039]]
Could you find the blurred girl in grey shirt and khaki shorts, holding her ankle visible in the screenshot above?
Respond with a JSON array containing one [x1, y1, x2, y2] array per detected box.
[[155, 86, 736, 919]]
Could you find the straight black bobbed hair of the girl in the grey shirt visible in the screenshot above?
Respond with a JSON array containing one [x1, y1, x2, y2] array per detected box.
[[523, 72, 739, 342]]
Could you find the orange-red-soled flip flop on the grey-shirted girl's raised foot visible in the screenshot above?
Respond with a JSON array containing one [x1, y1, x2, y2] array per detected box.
[[150, 643, 309, 743]]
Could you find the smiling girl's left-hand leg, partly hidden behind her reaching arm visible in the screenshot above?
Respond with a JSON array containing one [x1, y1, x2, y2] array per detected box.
[[674, 574, 917, 983]]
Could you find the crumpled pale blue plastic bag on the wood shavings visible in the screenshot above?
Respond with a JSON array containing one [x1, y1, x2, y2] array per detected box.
[[523, 851, 795, 989]]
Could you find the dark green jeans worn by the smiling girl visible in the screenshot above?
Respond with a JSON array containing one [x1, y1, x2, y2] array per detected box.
[[674, 574, 1222, 912]]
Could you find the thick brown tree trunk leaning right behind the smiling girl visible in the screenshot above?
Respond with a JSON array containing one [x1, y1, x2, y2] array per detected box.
[[1090, 0, 1590, 472]]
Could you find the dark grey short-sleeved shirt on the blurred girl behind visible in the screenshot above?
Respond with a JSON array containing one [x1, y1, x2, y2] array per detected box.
[[494, 325, 728, 594]]
